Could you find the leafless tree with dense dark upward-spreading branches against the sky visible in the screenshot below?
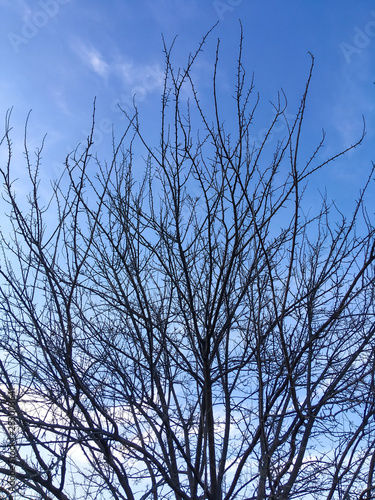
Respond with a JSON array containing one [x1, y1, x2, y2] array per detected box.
[[0, 30, 375, 500]]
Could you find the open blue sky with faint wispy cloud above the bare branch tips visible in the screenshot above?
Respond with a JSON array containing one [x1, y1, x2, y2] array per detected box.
[[0, 0, 375, 209]]
